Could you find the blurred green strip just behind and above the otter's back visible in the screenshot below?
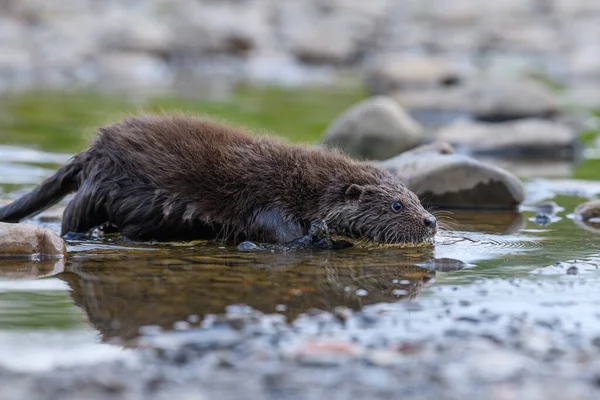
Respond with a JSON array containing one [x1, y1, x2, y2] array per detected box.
[[0, 86, 367, 152]]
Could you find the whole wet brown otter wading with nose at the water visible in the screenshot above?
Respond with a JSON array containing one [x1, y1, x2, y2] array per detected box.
[[0, 115, 437, 243]]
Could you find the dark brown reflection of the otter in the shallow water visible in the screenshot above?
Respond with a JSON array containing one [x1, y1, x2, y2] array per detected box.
[[58, 247, 433, 340]]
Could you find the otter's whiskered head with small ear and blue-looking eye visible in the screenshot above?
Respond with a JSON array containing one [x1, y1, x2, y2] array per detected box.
[[328, 180, 437, 243]]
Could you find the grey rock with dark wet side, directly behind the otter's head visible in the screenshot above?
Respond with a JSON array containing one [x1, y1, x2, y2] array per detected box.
[[379, 154, 525, 209]]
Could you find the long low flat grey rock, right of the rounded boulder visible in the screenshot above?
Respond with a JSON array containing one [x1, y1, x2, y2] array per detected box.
[[436, 118, 580, 159]]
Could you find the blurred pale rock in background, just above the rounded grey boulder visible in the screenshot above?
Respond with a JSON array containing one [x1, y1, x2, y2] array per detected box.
[[366, 55, 462, 94]]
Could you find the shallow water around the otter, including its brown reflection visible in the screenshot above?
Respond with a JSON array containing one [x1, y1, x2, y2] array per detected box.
[[0, 104, 600, 370]]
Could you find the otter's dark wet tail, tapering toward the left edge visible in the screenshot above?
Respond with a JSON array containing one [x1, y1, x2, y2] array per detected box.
[[0, 160, 82, 222]]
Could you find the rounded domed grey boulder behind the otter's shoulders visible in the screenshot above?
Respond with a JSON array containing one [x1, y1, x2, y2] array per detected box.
[[323, 96, 423, 160]]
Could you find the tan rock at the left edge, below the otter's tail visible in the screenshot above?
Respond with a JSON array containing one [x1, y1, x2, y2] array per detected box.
[[0, 222, 67, 258]]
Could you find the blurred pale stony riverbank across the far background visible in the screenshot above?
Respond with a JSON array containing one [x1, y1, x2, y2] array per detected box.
[[0, 0, 600, 107]]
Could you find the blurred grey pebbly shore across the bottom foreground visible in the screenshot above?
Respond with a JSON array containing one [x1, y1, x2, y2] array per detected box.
[[0, 276, 600, 400]]
